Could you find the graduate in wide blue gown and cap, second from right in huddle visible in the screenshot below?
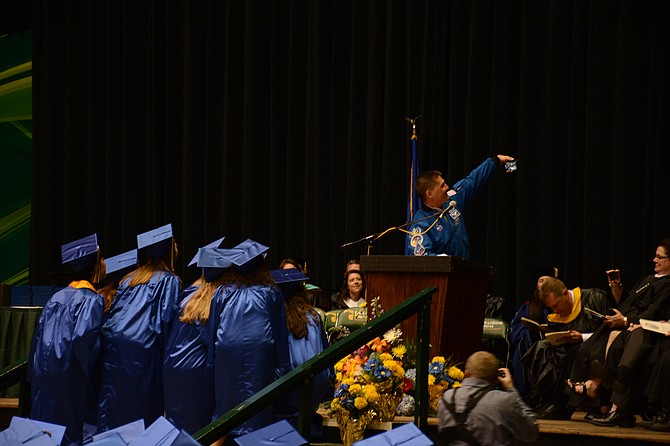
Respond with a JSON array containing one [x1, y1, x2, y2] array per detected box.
[[213, 240, 291, 441]]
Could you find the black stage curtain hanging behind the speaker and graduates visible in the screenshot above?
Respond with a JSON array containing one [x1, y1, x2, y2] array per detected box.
[[30, 0, 670, 313]]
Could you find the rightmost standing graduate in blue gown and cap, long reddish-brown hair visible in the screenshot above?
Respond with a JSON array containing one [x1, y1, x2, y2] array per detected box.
[[271, 268, 334, 439]]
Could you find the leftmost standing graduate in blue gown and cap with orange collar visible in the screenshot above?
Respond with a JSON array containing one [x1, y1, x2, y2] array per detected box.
[[28, 234, 105, 444]]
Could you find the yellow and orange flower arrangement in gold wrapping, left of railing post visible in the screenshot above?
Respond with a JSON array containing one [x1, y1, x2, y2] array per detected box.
[[330, 328, 407, 444]]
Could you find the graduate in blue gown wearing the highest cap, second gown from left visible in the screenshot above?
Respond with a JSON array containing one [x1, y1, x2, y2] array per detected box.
[[98, 224, 181, 432]]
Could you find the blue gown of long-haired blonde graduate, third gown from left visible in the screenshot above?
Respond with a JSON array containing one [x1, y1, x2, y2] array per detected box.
[[163, 286, 226, 434]]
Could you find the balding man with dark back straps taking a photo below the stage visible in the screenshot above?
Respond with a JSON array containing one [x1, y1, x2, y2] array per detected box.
[[436, 351, 539, 445]]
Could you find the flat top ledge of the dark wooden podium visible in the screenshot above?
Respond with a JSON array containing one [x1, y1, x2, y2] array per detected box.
[[361, 256, 494, 274]]
